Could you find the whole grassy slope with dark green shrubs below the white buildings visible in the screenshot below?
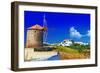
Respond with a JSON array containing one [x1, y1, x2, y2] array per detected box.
[[54, 45, 90, 60]]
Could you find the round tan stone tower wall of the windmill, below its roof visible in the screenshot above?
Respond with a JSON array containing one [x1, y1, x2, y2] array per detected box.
[[26, 30, 43, 48]]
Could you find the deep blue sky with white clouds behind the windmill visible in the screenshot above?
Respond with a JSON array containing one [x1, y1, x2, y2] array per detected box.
[[24, 11, 90, 43]]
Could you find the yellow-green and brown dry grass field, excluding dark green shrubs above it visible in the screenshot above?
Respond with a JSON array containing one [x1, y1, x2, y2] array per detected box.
[[55, 46, 90, 60]]
